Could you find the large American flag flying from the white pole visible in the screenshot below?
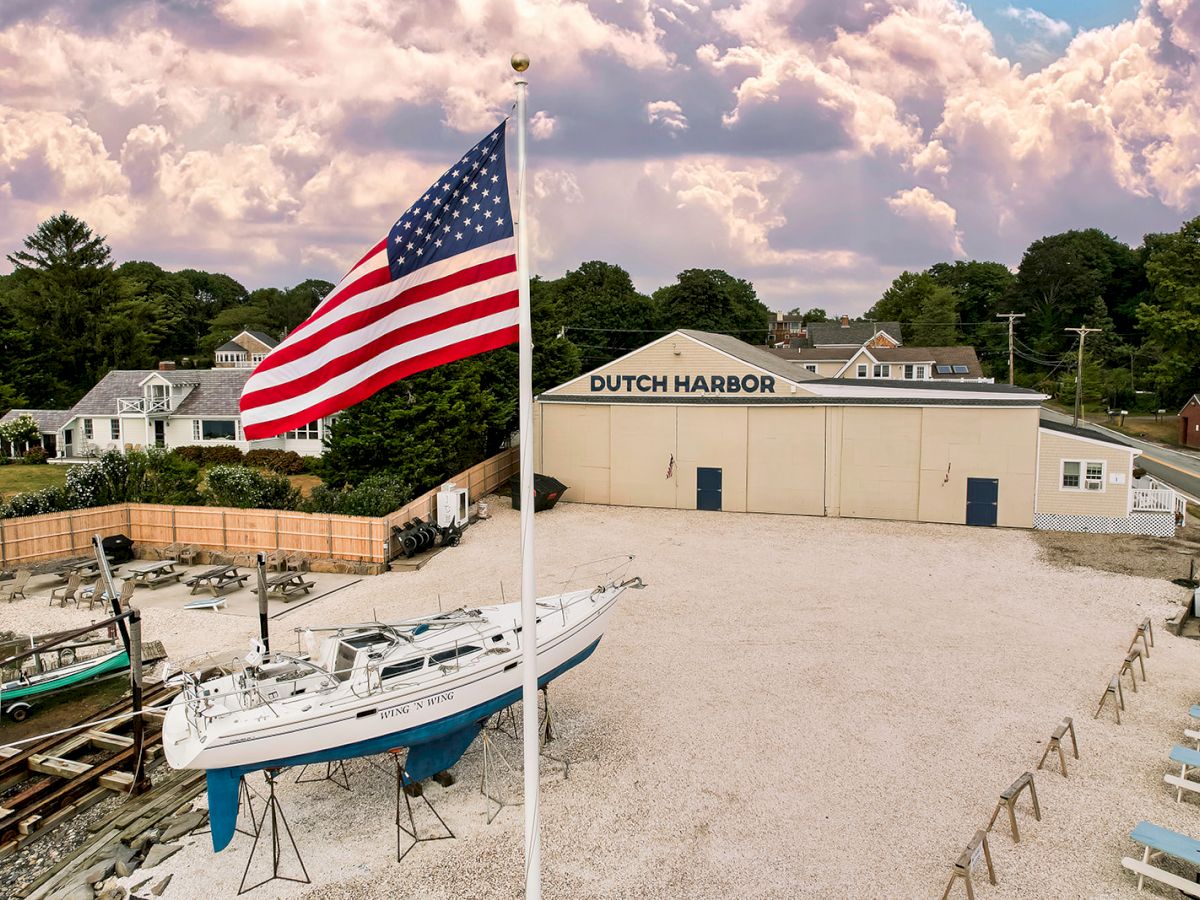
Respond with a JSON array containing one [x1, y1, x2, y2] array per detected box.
[[241, 122, 518, 440]]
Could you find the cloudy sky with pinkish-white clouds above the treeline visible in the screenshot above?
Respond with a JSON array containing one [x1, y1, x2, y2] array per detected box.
[[0, 0, 1200, 313]]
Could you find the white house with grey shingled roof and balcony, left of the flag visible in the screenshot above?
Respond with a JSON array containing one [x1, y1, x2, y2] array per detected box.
[[58, 364, 326, 460]]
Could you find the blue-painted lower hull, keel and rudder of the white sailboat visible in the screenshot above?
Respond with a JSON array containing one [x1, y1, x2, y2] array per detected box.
[[206, 637, 600, 852]]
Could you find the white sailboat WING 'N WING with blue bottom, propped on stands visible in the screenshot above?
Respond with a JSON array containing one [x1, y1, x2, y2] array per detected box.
[[162, 578, 642, 851]]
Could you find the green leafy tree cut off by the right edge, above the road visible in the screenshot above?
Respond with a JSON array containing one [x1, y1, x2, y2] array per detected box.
[[1138, 216, 1200, 403]]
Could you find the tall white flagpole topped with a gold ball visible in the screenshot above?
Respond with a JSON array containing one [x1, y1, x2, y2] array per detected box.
[[511, 53, 541, 900]]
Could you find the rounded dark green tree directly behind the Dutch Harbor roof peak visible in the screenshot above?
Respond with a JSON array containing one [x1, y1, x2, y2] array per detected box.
[[653, 269, 770, 343]]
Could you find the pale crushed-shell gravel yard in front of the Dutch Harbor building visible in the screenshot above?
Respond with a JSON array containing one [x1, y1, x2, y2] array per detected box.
[[2, 498, 1200, 900]]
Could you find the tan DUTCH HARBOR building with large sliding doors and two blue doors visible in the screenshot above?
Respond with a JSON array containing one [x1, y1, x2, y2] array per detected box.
[[534, 330, 1180, 528]]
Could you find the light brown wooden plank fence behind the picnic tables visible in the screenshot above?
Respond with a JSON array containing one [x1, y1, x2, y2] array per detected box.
[[0, 448, 518, 569]]
